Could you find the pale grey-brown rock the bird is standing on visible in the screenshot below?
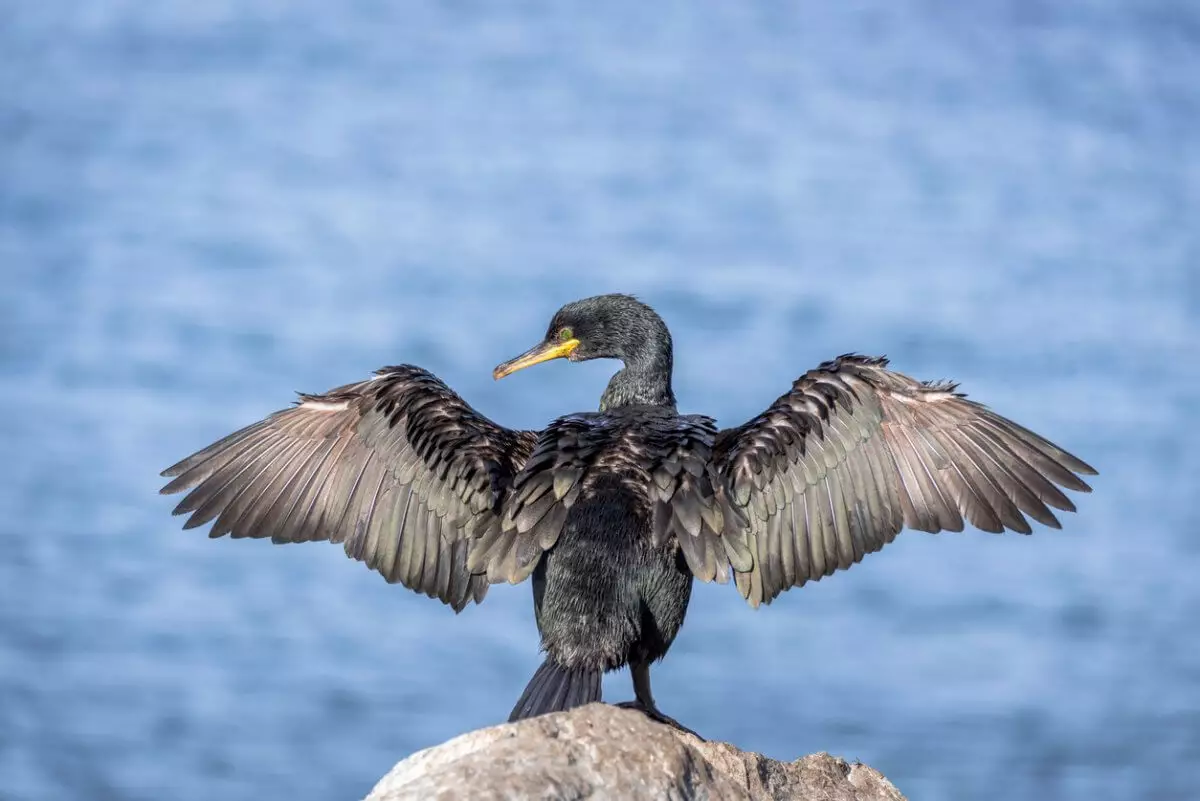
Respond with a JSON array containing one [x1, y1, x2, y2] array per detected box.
[[366, 704, 905, 801]]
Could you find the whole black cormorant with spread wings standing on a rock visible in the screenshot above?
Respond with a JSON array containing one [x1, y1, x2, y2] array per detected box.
[[162, 295, 1096, 728]]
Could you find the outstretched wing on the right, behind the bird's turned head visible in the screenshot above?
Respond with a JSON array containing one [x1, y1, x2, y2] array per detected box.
[[713, 354, 1096, 606]]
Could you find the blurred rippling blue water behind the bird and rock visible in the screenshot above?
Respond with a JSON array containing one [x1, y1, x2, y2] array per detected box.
[[0, 0, 1200, 801]]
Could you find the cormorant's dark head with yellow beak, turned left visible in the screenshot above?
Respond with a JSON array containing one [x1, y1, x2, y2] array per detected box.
[[492, 295, 671, 379]]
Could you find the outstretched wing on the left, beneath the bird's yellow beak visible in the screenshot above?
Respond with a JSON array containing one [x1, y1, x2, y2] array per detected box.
[[161, 365, 536, 612]]
